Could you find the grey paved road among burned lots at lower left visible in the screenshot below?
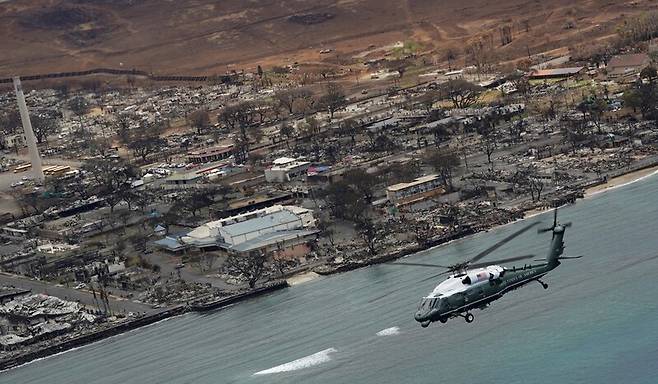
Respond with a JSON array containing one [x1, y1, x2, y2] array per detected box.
[[0, 272, 154, 312]]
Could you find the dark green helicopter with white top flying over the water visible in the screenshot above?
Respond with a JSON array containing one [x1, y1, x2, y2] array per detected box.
[[391, 208, 582, 328]]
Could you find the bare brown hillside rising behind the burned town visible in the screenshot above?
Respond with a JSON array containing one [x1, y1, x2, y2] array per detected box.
[[0, 0, 652, 77]]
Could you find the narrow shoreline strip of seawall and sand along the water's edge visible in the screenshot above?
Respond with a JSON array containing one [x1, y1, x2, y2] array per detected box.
[[0, 165, 658, 372]]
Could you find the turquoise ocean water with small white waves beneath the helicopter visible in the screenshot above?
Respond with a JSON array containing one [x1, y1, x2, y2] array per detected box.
[[0, 176, 658, 384]]
